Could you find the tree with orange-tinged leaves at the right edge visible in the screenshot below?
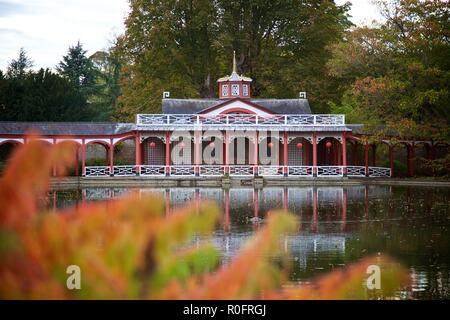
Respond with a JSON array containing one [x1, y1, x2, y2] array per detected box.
[[327, 0, 450, 140]]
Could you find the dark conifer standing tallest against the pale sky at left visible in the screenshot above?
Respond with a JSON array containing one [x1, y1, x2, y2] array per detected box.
[[56, 41, 97, 97]]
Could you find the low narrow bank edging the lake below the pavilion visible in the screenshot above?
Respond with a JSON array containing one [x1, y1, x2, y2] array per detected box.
[[50, 177, 450, 189]]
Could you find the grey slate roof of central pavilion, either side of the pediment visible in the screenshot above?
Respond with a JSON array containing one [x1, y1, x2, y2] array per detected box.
[[162, 99, 311, 114]]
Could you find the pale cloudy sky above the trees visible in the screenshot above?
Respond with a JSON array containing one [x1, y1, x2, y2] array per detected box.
[[0, 0, 379, 70]]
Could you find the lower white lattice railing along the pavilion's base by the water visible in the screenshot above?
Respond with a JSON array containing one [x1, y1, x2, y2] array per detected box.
[[83, 165, 391, 178]]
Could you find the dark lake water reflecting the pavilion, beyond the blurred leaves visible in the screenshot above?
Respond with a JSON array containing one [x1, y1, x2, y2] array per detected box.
[[48, 185, 450, 299]]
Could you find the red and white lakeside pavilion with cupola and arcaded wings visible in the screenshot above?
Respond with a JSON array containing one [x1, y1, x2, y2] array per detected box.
[[0, 53, 442, 178]]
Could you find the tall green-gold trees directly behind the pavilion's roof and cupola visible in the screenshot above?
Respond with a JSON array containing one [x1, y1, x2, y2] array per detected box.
[[116, 0, 350, 119]]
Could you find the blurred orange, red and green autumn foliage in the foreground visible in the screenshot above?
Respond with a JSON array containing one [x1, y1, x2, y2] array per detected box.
[[0, 141, 408, 299]]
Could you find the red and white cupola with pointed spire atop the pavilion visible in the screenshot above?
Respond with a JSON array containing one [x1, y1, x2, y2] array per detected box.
[[217, 51, 252, 99]]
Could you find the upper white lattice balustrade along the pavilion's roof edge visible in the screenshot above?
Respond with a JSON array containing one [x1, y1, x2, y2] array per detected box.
[[136, 114, 345, 126]]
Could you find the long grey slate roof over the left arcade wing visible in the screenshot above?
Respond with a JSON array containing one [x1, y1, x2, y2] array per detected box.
[[0, 121, 136, 136]]
